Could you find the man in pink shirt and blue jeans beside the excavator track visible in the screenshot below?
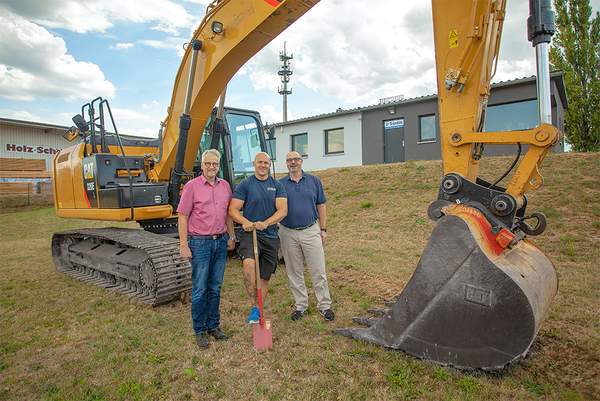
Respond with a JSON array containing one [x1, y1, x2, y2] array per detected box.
[[177, 149, 235, 348]]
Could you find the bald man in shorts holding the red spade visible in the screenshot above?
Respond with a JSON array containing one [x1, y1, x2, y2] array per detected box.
[[229, 152, 287, 324]]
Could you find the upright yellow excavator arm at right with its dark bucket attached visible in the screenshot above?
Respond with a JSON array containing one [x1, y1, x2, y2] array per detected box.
[[338, 0, 559, 370]]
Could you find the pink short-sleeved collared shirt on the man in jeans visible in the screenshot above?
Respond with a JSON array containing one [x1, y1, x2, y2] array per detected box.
[[177, 175, 231, 235]]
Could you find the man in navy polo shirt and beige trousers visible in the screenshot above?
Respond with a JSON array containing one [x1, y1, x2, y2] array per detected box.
[[279, 152, 335, 321]]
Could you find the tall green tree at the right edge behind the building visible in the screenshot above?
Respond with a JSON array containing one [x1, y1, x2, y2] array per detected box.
[[550, 0, 600, 152]]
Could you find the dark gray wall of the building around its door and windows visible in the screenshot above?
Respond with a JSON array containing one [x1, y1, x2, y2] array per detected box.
[[362, 73, 566, 164]]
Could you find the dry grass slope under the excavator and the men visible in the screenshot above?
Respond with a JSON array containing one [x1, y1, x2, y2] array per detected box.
[[0, 154, 600, 400]]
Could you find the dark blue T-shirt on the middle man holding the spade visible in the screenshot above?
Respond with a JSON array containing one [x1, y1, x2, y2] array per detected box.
[[233, 175, 287, 238]]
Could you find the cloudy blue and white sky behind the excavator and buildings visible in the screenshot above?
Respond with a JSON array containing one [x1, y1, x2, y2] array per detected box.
[[0, 0, 600, 137]]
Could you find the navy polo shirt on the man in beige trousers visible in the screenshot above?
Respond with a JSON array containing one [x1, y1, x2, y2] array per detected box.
[[279, 171, 327, 228]]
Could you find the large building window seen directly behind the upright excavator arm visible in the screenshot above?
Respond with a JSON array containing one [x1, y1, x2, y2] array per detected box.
[[483, 99, 539, 132]]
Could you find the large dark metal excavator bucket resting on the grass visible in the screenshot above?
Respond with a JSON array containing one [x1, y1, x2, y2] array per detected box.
[[337, 205, 558, 370]]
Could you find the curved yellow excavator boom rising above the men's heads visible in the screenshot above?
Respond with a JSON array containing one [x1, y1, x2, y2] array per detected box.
[[150, 0, 318, 181]]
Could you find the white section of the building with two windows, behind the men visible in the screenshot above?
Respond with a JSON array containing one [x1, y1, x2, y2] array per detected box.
[[275, 111, 362, 172]]
